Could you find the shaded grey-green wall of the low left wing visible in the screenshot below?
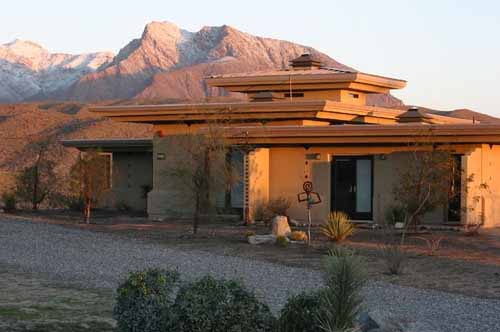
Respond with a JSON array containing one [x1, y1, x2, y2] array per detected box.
[[104, 152, 153, 211]]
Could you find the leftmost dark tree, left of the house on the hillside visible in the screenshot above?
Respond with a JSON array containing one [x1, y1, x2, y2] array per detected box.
[[16, 141, 57, 210]]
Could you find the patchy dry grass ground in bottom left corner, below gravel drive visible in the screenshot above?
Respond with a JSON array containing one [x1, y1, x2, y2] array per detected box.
[[0, 265, 116, 332]]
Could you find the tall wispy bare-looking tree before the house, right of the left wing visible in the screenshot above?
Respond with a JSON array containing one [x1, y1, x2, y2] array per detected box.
[[164, 122, 238, 234]]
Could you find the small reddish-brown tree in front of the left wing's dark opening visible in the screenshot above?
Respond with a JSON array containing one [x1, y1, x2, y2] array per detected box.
[[70, 151, 110, 224]]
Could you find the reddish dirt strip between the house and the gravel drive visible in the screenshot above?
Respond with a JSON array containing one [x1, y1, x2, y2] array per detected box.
[[3, 211, 500, 298]]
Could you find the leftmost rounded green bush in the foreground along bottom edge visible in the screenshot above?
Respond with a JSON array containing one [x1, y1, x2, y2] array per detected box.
[[113, 269, 179, 332]]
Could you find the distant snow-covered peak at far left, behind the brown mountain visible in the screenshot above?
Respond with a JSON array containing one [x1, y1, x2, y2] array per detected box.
[[0, 40, 113, 102]]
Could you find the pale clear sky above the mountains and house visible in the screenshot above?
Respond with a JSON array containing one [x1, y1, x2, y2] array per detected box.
[[0, 0, 500, 116]]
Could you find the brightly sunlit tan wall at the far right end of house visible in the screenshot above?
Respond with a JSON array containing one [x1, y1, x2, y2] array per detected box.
[[462, 144, 500, 227]]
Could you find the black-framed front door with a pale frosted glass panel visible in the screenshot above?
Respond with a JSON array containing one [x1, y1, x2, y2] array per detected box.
[[331, 156, 373, 220]]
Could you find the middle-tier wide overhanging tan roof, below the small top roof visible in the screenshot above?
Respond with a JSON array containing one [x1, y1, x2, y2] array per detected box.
[[90, 100, 471, 124]]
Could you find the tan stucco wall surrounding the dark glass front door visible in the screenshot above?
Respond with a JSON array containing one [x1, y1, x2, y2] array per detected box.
[[269, 147, 458, 223]]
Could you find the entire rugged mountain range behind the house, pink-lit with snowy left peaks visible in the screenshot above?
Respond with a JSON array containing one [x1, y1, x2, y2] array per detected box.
[[0, 22, 402, 106]]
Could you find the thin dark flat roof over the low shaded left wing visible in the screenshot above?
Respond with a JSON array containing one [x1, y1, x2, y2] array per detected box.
[[61, 139, 153, 152]]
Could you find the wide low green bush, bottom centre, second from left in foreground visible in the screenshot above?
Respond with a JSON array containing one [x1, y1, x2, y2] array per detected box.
[[172, 276, 274, 332]]
